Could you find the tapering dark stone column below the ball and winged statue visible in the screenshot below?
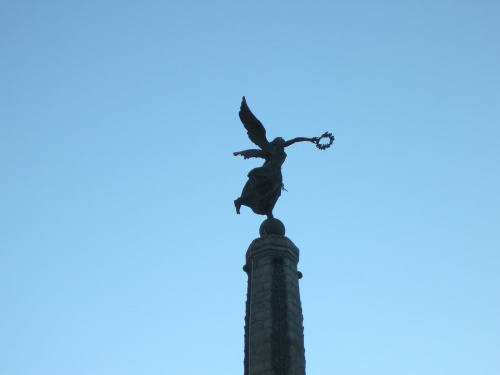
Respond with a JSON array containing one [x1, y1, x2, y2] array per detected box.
[[243, 235, 305, 375]]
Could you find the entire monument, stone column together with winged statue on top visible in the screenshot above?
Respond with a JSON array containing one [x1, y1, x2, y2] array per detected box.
[[234, 97, 334, 375]]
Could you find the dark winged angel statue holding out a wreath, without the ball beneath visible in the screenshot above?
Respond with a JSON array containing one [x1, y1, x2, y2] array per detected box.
[[233, 97, 334, 220]]
